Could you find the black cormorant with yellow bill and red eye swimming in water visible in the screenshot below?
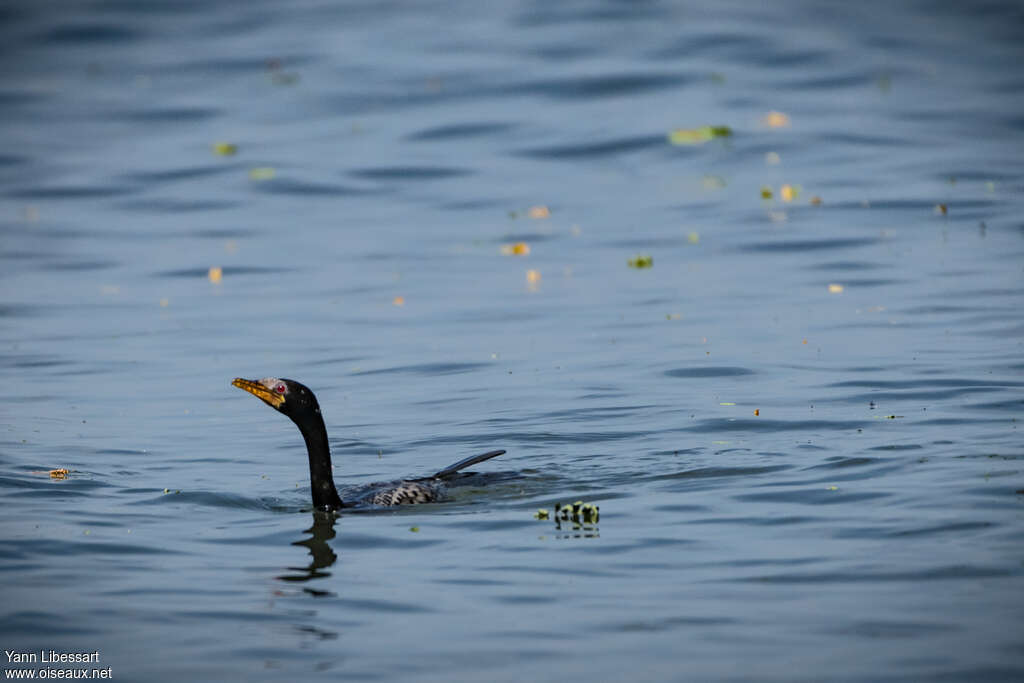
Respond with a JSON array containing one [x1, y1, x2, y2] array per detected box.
[[231, 377, 505, 512]]
